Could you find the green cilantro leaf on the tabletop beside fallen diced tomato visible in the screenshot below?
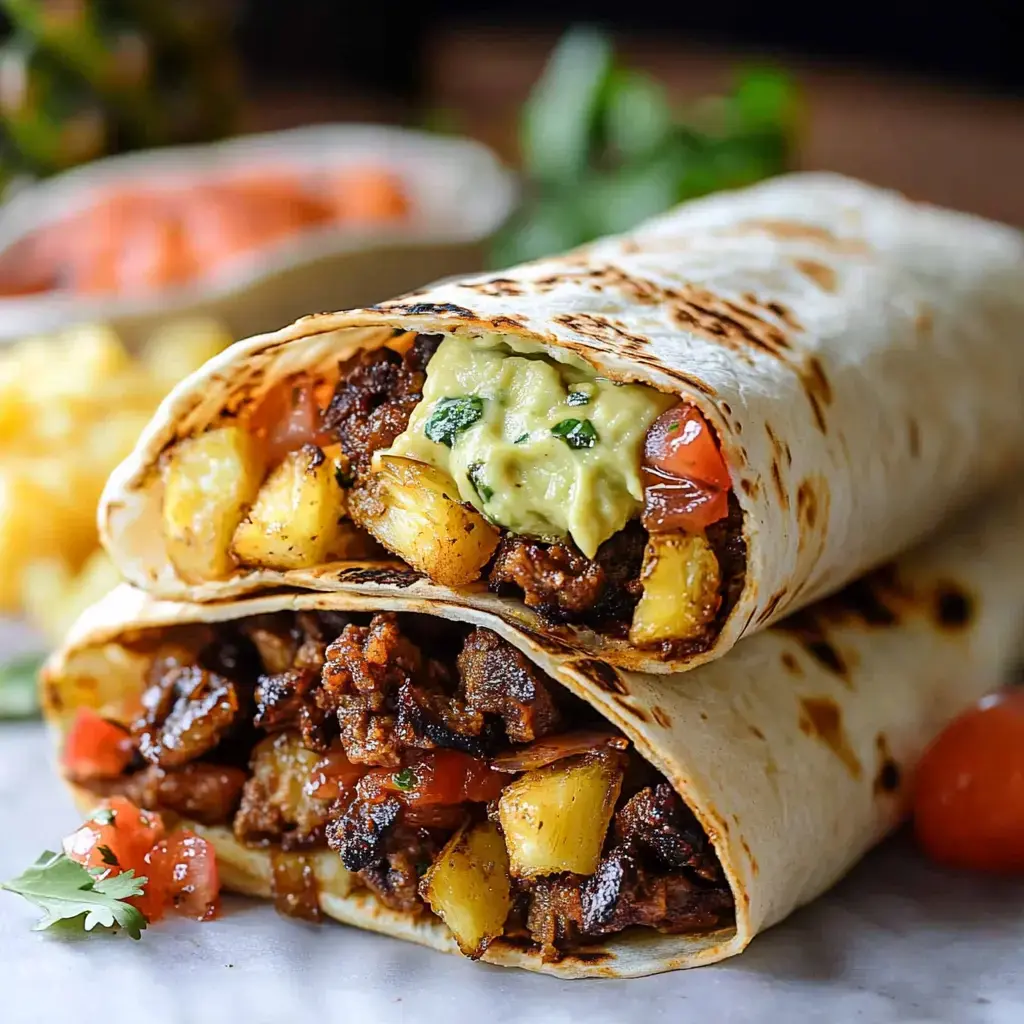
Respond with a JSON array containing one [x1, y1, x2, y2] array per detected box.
[[0, 850, 148, 939]]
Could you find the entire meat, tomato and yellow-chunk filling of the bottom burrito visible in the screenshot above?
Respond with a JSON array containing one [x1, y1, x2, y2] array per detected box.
[[62, 612, 733, 959]]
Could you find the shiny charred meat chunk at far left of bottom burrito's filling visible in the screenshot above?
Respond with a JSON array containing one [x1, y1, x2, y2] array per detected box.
[[132, 659, 242, 768]]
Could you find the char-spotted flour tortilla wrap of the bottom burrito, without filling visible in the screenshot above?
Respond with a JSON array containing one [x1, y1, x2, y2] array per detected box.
[[44, 493, 1024, 978]]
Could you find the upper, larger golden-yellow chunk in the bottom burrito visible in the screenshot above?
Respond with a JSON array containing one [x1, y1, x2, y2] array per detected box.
[[498, 752, 623, 879]]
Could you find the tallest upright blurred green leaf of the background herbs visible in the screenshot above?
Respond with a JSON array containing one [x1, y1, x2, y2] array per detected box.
[[520, 27, 612, 181]]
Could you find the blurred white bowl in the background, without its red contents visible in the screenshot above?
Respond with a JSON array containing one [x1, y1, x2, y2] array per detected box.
[[0, 125, 518, 344]]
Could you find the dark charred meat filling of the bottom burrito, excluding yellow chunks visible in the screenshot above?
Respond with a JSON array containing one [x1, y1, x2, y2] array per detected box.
[[83, 612, 732, 958]]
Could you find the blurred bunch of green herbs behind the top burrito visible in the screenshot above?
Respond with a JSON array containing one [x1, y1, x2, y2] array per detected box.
[[492, 28, 798, 267]]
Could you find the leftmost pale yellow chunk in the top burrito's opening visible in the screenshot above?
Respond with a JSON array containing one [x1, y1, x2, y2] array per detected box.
[[163, 427, 263, 583]]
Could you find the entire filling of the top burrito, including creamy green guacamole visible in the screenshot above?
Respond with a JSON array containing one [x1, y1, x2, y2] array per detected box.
[[157, 333, 745, 655]]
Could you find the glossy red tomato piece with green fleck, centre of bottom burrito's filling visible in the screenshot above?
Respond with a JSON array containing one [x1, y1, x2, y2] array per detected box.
[[356, 751, 509, 807]]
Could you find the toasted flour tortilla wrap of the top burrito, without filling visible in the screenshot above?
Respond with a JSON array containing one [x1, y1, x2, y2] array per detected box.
[[99, 174, 1024, 672]]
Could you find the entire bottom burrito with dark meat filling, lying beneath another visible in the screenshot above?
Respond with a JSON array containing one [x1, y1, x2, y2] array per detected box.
[[43, 483, 1024, 978]]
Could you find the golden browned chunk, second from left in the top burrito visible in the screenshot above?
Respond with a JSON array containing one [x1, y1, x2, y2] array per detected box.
[[231, 444, 354, 569]]
